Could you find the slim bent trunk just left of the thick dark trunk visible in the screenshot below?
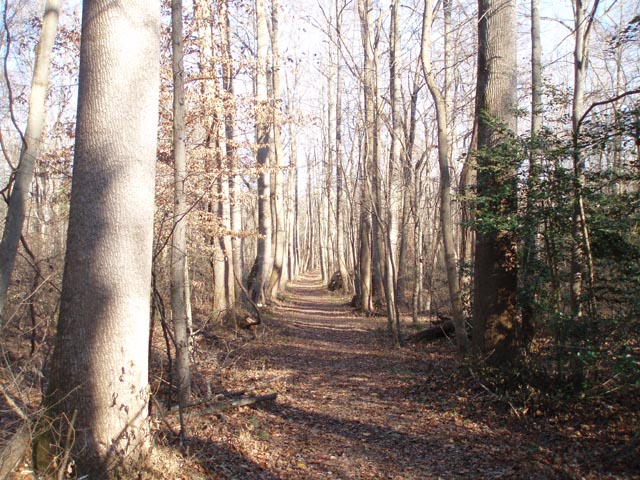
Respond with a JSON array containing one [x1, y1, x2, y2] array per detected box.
[[421, 0, 468, 356]]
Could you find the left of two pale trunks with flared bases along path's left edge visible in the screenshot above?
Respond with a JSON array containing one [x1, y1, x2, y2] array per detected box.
[[248, 0, 273, 303]]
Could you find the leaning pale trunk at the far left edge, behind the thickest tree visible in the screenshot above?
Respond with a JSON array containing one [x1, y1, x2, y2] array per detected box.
[[0, 0, 61, 325]]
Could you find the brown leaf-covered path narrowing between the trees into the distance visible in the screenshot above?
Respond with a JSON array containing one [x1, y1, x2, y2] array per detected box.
[[156, 276, 616, 480]]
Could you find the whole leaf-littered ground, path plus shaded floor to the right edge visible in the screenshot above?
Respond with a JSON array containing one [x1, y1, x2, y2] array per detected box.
[[148, 275, 640, 480]]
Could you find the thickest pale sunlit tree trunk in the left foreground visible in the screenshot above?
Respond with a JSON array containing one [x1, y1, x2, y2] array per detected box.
[[36, 0, 160, 472]]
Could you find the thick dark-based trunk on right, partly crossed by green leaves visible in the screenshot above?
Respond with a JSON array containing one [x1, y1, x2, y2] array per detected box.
[[473, 0, 520, 362]]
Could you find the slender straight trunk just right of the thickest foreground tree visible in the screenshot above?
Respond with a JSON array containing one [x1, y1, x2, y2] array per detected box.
[[171, 0, 191, 428]]
